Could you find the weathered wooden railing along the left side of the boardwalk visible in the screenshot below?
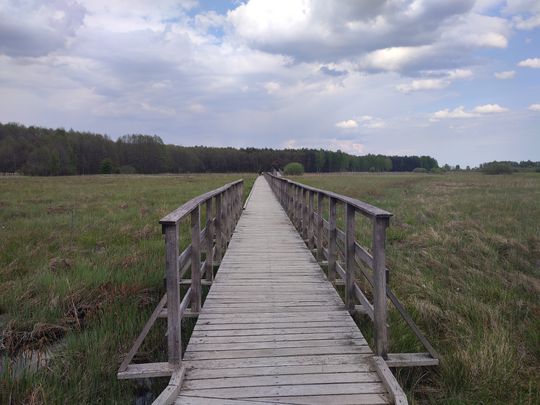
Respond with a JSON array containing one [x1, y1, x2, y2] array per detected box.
[[118, 180, 244, 379]]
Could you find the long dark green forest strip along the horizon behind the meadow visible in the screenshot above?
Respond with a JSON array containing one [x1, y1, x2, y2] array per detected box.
[[0, 123, 438, 176]]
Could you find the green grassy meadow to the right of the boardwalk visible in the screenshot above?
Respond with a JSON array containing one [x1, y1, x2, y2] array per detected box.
[[295, 173, 540, 404]]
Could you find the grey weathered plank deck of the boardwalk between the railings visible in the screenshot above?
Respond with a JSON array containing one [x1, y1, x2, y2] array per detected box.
[[175, 176, 400, 405]]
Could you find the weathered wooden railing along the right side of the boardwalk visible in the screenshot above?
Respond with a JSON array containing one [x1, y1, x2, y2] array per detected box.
[[265, 173, 439, 367]]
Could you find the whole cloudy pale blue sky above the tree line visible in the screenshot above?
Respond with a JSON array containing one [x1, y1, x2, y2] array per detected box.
[[0, 0, 540, 167]]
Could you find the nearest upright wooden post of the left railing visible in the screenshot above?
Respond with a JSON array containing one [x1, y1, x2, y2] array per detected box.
[[162, 224, 182, 366]]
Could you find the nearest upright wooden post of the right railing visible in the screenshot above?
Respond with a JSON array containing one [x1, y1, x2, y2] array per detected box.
[[372, 217, 389, 359]]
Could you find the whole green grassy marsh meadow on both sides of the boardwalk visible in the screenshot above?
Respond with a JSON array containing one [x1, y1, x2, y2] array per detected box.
[[0, 173, 540, 404]]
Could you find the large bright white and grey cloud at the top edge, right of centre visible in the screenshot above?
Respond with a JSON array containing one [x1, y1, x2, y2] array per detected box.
[[227, 0, 509, 75]]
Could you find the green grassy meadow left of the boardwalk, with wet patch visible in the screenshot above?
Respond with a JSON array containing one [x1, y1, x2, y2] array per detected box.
[[0, 175, 255, 404]]
